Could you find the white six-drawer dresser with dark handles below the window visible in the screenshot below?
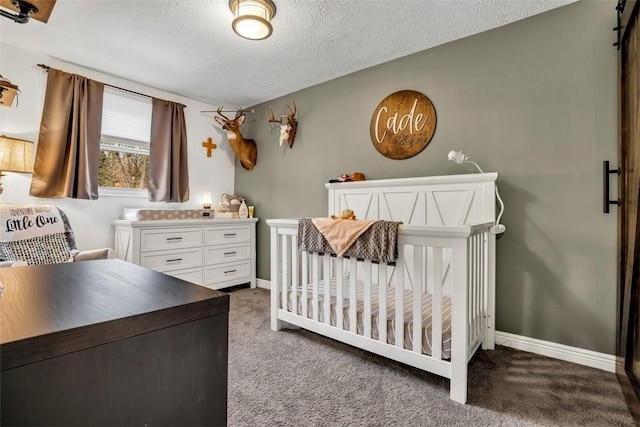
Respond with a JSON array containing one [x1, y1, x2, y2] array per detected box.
[[114, 218, 258, 289]]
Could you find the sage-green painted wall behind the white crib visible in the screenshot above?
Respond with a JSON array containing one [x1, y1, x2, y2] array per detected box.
[[235, 0, 617, 354]]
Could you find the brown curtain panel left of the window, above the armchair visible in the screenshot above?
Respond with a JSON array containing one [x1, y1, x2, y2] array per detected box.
[[30, 69, 104, 200]]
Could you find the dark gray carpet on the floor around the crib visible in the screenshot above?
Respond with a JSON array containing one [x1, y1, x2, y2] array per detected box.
[[228, 289, 634, 426]]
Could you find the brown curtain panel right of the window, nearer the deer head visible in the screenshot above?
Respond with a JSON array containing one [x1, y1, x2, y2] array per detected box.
[[149, 98, 189, 202]]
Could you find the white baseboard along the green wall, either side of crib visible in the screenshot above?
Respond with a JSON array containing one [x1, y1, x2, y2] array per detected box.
[[251, 279, 616, 373]]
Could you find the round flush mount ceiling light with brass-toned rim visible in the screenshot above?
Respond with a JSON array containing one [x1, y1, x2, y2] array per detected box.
[[229, 0, 276, 40]]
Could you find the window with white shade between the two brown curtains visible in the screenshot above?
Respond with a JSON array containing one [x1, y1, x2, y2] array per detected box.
[[98, 87, 152, 190]]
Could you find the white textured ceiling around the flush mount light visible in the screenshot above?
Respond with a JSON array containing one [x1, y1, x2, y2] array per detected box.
[[0, 0, 575, 107]]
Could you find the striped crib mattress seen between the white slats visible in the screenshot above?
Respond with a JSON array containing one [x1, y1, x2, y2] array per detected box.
[[287, 280, 451, 359]]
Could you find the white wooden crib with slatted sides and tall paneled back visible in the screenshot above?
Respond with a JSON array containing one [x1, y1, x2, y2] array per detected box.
[[267, 173, 498, 403]]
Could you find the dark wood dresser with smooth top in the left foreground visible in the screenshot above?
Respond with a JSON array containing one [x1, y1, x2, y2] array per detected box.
[[0, 260, 229, 426]]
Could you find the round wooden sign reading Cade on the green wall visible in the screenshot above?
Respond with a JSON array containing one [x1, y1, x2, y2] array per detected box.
[[369, 90, 436, 160]]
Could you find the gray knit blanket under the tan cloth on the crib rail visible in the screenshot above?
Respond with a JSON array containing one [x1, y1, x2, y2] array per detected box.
[[298, 218, 402, 262]]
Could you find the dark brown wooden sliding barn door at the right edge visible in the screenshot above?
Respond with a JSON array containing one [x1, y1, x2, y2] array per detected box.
[[617, 1, 640, 422]]
